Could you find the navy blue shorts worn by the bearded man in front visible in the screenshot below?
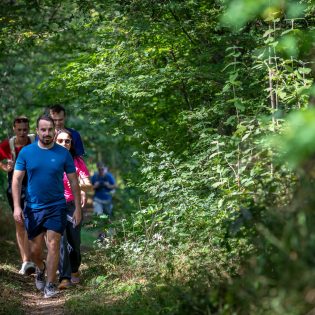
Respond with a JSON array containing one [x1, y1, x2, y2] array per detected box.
[[23, 203, 67, 240]]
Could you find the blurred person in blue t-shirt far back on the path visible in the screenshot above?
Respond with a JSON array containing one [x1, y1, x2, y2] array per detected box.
[[91, 162, 116, 218]]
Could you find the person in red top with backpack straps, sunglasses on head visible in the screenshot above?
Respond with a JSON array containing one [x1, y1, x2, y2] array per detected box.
[[0, 116, 35, 275]]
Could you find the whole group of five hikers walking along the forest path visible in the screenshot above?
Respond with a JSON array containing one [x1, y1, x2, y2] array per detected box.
[[0, 105, 116, 298]]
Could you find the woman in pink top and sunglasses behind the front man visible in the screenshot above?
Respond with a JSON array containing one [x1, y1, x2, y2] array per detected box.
[[56, 129, 92, 289]]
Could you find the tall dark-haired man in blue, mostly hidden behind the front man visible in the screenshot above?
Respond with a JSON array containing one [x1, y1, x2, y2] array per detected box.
[[49, 104, 85, 156]]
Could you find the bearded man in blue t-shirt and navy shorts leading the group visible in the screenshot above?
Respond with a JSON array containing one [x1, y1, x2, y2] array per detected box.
[[12, 115, 81, 298]]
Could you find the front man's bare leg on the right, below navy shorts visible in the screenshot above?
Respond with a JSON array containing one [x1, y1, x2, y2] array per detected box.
[[46, 230, 61, 283]]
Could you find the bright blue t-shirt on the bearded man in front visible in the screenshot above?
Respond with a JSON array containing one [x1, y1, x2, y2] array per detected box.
[[14, 142, 76, 209]]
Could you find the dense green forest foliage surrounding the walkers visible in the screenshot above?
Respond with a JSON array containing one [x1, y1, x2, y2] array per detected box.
[[0, 0, 315, 314]]
